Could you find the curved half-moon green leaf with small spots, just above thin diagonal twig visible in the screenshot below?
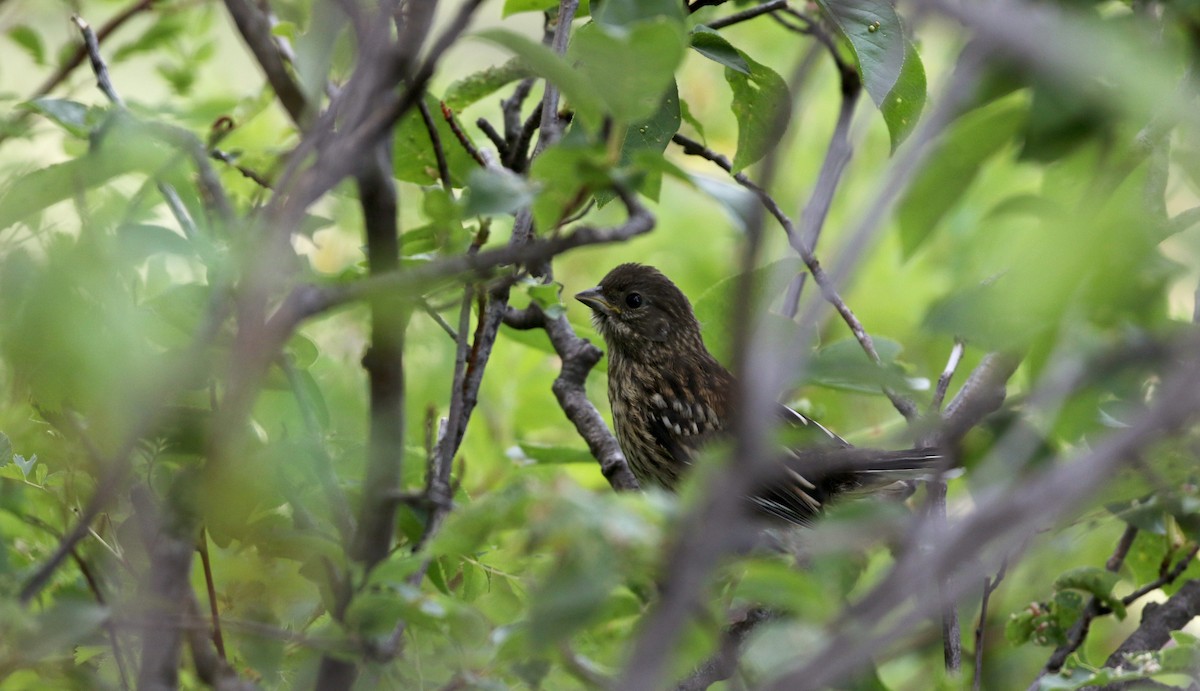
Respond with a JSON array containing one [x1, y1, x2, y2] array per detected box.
[[725, 50, 792, 173]]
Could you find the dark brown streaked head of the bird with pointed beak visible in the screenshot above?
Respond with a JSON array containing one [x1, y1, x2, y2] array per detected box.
[[575, 264, 703, 353]]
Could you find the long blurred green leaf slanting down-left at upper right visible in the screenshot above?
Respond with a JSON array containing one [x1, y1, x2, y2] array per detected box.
[[898, 97, 1026, 258]]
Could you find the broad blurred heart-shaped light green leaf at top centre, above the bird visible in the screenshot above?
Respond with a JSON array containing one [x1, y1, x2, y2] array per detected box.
[[568, 18, 685, 124]]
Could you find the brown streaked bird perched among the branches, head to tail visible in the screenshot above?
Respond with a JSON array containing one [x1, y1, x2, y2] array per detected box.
[[575, 264, 940, 524]]
